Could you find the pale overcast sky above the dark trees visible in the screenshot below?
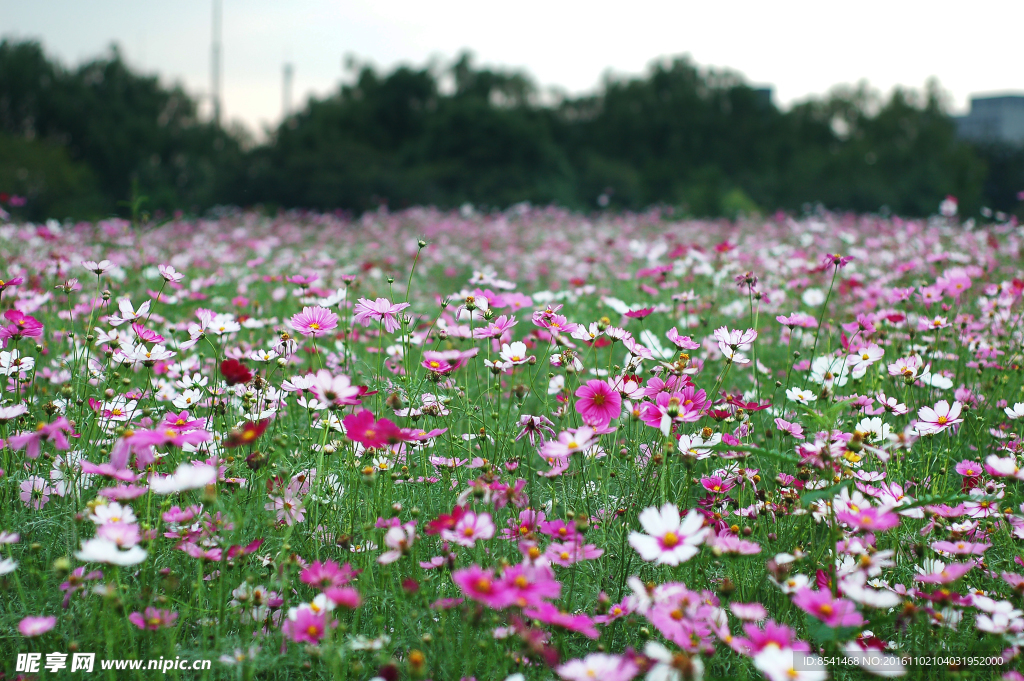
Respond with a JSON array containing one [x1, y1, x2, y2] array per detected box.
[[0, 0, 1024, 132]]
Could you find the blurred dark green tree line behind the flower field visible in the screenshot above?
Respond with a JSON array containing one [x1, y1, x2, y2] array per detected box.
[[0, 41, 1024, 219]]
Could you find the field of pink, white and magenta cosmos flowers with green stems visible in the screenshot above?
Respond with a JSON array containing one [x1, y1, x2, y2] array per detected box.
[[0, 207, 1024, 681]]
